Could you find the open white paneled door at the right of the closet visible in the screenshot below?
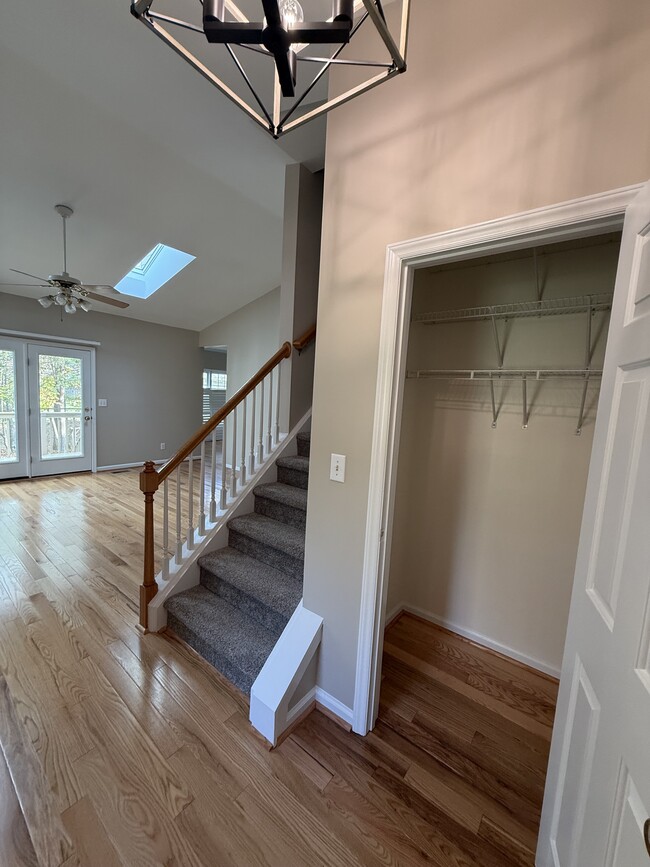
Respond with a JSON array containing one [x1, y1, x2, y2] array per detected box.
[[537, 185, 650, 867]]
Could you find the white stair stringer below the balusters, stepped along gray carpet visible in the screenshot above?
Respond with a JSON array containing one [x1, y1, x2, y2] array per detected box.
[[148, 410, 311, 632]]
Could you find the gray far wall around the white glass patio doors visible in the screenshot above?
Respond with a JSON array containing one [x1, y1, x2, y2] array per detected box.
[[0, 293, 203, 467]]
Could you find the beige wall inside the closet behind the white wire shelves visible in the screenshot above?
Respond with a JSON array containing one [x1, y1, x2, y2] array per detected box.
[[387, 235, 620, 674]]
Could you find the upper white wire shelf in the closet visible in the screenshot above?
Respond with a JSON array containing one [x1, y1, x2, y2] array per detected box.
[[413, 293, 613, 325]]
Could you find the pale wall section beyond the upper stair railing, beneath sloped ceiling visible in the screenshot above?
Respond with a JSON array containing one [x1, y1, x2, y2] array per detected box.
[[199, 288, 280, 398]]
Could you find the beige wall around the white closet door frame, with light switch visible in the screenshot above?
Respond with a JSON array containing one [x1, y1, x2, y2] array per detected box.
[[305, 0, 650, 706]]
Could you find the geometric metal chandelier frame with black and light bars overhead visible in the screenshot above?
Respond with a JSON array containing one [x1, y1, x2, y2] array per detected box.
[[131, 0, 411, 139]]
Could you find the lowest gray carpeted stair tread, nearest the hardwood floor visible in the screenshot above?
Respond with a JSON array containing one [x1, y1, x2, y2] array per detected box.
[[165, 584, 277, 679]]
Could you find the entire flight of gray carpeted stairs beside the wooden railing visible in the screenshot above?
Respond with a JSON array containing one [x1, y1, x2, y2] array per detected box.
[[165, 433, 309, 693]]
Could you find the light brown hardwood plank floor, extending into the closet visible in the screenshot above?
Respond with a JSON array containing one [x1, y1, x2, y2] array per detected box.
[[0, 472, 556, 867]]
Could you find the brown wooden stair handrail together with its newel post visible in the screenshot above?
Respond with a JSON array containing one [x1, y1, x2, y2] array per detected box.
[[140, 325, 316, 631]]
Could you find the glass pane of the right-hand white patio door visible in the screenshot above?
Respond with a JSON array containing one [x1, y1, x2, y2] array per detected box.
[[38, 353, 84, 460]]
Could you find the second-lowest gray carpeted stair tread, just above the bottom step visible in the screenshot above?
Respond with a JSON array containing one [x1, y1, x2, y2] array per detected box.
[[199, 547, 302, 620]]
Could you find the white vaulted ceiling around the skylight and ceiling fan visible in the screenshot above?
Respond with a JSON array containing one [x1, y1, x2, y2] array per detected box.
[[0, 0, 324, 330]]
